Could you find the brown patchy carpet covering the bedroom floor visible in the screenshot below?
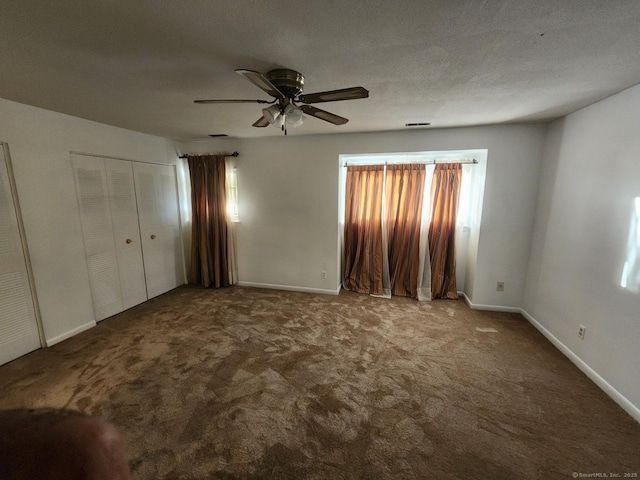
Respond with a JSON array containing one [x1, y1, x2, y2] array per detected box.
[[0, 287, 640, 480]]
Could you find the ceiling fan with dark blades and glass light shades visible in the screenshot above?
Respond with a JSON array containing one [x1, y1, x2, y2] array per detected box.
[[194, 68, 369, 135]]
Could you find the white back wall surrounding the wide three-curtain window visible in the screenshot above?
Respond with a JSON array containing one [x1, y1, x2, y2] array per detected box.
[[180, 124, 546, 308]]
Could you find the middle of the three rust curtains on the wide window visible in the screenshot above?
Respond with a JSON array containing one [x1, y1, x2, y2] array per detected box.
[[385, 164, 426, 298]]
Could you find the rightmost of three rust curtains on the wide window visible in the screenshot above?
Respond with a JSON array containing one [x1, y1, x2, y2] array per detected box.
[[429, 163, 462, 299]]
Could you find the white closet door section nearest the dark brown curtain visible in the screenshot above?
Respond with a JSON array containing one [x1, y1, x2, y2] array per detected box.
[[133, 163, 184, 298]]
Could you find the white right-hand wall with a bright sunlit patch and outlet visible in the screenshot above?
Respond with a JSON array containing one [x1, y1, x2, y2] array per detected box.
[[523, 86, 640, 418]]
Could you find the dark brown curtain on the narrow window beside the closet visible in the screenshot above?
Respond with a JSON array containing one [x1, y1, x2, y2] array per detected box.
[[187, 155, 230, 288]]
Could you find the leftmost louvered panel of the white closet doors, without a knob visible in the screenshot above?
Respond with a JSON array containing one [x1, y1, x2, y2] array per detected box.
[[72, 154, 124, 320]]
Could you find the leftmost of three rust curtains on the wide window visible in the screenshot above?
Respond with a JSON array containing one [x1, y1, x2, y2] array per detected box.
[[343, 165, 386, 295]]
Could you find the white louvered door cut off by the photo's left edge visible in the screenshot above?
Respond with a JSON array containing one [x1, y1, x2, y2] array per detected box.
[[0, 144, 41, 364]]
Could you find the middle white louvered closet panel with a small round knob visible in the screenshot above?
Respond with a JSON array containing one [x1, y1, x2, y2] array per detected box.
[[104, 158, 147, 309]]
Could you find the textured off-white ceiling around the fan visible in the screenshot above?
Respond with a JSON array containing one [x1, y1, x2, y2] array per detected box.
[[0, 0, 640, 139]]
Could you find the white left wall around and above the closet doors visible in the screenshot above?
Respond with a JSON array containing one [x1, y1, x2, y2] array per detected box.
[[0, 99, 184, 344]]
